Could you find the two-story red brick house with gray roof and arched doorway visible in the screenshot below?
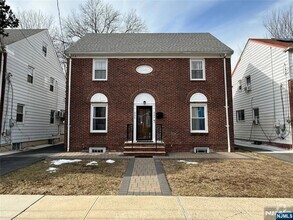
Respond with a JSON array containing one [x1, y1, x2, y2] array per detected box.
[[66, 33, 233, 154]]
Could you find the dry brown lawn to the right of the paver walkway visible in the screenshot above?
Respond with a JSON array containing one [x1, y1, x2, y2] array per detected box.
[[162, 154, 293, 198]]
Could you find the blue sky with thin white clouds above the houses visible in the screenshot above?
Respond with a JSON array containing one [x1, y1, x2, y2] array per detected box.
[[7, 0, 293, 68]]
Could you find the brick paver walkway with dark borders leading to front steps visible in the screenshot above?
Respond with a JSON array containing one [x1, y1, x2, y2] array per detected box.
[[119, 158, 171, 195]]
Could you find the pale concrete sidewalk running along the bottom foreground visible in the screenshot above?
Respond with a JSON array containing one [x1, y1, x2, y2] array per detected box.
[[0, 195, 293, 220]]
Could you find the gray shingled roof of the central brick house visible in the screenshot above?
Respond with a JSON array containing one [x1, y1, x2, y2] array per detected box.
[[66, 33, 233, 54]]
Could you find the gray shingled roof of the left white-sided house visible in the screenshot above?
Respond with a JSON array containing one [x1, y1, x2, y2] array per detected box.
[[4, 29, 46, 45]]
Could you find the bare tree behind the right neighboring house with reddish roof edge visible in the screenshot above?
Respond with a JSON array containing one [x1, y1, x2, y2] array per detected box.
[[263, 6, 293, 39]]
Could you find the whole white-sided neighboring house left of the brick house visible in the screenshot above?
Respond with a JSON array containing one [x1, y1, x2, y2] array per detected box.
[[0, 29, 66, 149]]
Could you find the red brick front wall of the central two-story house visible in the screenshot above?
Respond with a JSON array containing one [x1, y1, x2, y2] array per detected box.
[[65, 58, 234, 151]]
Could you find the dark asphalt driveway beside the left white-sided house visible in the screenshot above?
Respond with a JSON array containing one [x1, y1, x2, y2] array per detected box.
[[0, 144, 64, 176]]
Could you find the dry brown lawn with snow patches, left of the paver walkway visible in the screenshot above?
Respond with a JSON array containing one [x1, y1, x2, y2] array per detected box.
[[0, 160, 128, 195]]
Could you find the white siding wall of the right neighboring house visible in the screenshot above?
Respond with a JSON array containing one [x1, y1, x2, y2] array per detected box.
[[232, 41, 292, 144]]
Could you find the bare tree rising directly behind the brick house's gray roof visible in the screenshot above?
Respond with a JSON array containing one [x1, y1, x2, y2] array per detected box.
[[64, 0, 147, 38]]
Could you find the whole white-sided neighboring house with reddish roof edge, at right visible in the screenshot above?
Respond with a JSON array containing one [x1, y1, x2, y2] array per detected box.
[[232, 39, 293, 148]]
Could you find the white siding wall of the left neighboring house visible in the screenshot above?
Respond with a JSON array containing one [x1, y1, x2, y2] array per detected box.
[[1, 30, 65, 144]]
